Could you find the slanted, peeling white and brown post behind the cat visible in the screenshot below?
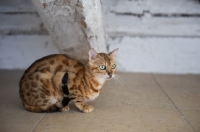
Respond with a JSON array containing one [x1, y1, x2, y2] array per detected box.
[[32, 0, 106, 62]]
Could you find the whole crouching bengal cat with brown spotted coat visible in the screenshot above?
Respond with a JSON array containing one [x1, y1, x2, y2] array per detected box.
[[19, 49, 118, 112]]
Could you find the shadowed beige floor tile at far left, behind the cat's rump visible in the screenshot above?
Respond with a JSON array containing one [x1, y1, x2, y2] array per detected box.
[[0, 71, 45, 132]]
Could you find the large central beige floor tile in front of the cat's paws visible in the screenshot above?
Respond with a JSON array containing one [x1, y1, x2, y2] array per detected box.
[[34, 73, 192, 132]]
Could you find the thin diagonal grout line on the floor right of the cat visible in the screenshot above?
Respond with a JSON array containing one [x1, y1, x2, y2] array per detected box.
[[151, 74, 196, 132]]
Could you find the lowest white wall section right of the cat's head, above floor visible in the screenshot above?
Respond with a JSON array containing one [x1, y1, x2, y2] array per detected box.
[[109, 37, 200, 74]]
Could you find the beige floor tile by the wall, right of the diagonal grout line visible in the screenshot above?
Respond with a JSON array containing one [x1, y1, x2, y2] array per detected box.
[[155, 75, 200, 109]]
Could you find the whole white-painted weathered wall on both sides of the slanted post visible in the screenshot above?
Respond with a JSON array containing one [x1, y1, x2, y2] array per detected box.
[[0, 0, 200, 74]]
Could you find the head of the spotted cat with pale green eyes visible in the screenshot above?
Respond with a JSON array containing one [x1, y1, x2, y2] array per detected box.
[[88, 48, 118, 79]]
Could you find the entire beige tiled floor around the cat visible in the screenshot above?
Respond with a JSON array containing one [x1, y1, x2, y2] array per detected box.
[[0, 70, 200, 132]]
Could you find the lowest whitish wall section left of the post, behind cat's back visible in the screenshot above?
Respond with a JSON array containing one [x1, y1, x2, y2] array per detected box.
[[0, 35, 59, 69]]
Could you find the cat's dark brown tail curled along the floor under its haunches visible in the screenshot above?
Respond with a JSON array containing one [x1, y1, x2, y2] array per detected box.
[[23, 102, 59, 113]]
